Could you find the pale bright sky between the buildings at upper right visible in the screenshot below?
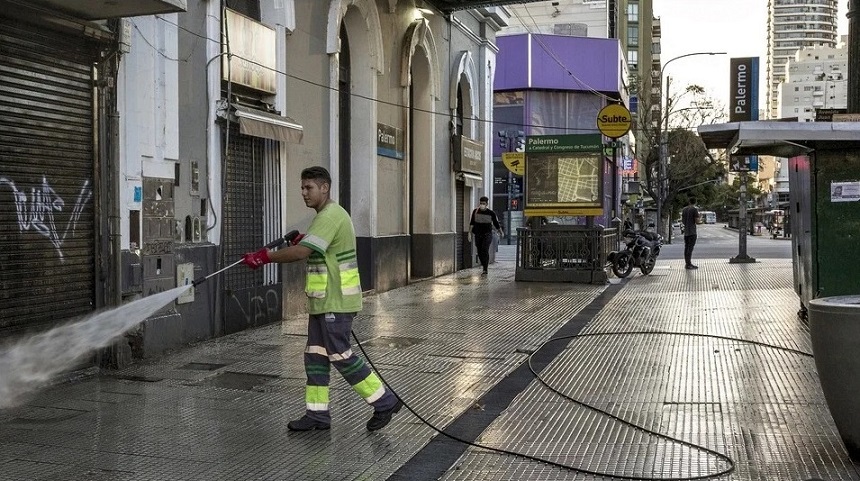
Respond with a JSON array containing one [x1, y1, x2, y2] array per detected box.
[[654, 0, 848, 114]]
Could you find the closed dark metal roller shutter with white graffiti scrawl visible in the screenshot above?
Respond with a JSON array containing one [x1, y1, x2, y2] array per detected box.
[[0, 17, 98, 338]]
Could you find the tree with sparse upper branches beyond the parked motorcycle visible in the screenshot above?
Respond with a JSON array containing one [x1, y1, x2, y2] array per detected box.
[[634, 85, 726, 236]]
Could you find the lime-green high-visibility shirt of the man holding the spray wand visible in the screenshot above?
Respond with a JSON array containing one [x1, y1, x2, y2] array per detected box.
[[299, 202, 361, 314]]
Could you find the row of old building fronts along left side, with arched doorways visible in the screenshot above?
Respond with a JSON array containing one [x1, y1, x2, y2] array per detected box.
[[0, 0, 524, 363]]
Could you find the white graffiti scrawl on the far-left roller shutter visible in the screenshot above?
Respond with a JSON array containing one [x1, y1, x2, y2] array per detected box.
[[0, 176, 93, 259]]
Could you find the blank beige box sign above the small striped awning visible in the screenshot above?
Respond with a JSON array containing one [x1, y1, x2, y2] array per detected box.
[[221, 9, 276, 93]]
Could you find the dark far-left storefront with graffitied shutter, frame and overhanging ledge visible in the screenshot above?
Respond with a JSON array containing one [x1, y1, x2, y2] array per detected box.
[[0, 0, 185, 344]]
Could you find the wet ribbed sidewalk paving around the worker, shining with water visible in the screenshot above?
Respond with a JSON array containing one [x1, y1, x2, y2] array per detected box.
[[0, 246, 860, 481]]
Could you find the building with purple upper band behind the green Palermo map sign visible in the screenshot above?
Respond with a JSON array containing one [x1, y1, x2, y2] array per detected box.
[[493, 34, 629, 229]]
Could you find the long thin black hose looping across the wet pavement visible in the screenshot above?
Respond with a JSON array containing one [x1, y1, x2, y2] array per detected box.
[[352, 331, 812, 481]]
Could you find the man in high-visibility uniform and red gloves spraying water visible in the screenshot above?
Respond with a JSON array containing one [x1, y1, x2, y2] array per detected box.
[[243, 167, 402, 431]]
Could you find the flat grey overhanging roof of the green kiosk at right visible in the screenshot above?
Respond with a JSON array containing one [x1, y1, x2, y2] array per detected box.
[[698, 120, 860, 157]]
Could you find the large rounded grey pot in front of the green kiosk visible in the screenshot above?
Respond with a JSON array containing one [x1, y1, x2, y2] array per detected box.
[[809, 295, 860, 461]]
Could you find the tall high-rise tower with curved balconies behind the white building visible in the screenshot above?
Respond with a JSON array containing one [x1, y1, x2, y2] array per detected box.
[[767, 0, 837, 118]]
